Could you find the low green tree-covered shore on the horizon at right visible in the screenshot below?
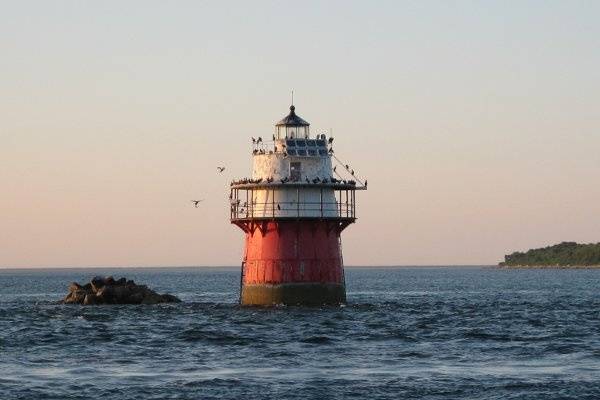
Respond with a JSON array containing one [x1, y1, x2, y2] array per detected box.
[[500, 242, 600, 267]]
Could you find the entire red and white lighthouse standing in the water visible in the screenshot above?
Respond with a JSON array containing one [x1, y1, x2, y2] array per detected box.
[[229, 105, 367, 305]]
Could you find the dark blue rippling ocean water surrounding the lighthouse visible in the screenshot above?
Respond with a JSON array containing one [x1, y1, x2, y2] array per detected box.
[[0, 267, 600, 400]]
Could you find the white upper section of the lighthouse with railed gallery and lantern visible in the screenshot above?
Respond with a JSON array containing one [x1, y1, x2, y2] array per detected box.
[[229, 105, 366, 223]]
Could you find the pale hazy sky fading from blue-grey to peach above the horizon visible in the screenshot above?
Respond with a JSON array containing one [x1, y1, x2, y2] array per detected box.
[[0, 0, 600, 267]]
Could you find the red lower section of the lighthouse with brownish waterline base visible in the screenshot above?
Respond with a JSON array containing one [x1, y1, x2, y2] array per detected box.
[[240, 220, 346, 305]]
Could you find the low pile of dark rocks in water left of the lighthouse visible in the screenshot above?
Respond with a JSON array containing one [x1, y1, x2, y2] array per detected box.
[[61, 276, 181, 305]]
